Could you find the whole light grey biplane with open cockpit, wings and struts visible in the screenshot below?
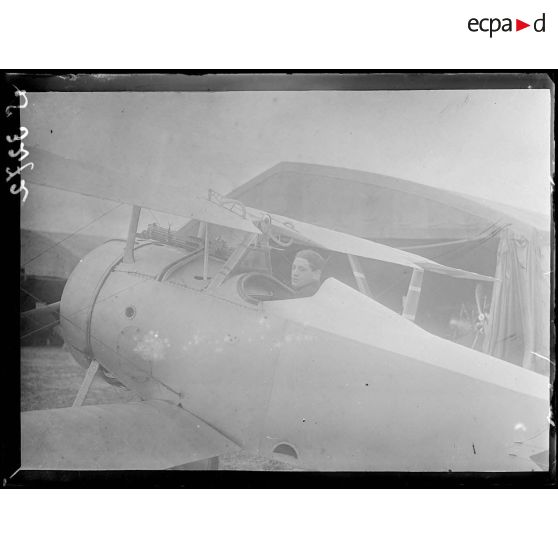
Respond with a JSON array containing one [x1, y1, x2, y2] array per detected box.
[[21, 147, 549, 471]]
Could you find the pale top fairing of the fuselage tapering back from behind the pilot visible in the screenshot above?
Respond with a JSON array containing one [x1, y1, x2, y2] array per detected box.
[[264, 278, 549, 401]]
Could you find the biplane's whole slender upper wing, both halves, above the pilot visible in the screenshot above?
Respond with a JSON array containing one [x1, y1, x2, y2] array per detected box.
[[28, 147, 494, 281]]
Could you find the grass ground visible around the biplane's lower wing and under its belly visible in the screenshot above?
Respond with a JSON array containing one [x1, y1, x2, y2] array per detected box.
[[21, 347, 299, 471]]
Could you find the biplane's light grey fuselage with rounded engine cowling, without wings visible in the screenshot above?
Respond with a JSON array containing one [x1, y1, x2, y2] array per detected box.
[[61, 241, 548, 471]]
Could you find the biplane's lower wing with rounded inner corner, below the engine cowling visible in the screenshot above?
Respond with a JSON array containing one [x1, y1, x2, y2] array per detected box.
[[21, 401, 237, 471]]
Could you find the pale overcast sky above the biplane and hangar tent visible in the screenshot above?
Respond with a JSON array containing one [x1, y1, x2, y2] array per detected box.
[[21, 90, 551, 236]]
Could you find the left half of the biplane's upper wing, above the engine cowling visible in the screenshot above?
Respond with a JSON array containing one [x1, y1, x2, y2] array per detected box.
[[26, 147, 259, 233]]
